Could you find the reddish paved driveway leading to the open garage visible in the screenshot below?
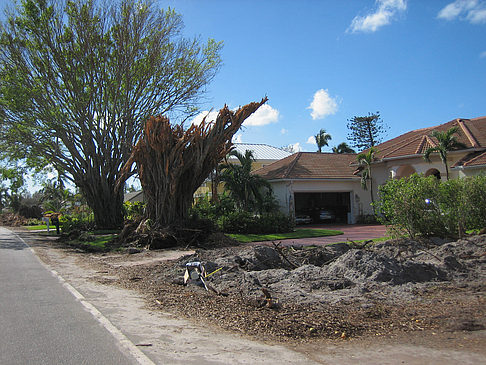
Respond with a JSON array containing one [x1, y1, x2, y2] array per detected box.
[[253, 224, 386, 246]]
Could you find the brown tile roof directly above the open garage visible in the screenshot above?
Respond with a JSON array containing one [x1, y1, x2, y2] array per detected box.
[[254, 152, 356, 180]]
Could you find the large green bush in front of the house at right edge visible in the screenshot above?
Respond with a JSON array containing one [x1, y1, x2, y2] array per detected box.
[[376, 174, 486, 237]]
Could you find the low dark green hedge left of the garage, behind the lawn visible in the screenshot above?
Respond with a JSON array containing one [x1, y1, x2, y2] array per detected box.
[[218, 211, 295, 234]]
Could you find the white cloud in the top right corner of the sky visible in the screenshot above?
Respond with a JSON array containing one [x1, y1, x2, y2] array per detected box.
[[437, 0, 486, 24]]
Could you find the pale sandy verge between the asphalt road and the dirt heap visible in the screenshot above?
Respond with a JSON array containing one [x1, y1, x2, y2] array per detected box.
[[17, 231, 486, 365]]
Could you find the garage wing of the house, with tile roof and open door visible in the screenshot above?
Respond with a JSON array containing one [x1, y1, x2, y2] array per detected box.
[[255, 152, 364, 223]]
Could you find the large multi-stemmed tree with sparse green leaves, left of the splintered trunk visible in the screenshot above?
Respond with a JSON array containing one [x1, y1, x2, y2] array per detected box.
[[0, 0, 221, 228]]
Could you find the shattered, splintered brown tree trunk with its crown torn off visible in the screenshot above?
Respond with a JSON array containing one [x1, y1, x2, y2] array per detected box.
[[122, 98, 267, 245]]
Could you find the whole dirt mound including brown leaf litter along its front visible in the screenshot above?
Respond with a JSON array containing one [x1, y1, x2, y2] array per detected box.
[[78, 235, 486, 342]]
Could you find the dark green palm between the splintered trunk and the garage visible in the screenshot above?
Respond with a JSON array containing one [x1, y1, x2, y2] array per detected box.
[[220, 150, 271, 211]]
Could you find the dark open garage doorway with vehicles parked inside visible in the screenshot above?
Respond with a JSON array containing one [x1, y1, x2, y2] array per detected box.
[[294, 192, 351, 223]]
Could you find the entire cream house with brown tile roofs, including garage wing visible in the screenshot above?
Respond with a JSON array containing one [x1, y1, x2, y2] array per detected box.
[[255, 117, 486, 223]]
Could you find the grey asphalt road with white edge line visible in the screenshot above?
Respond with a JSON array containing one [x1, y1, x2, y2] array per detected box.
[[0, 227, 142, 365]]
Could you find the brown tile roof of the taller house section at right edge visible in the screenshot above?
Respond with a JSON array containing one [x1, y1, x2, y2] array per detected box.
[[370, 117, 486, 159]]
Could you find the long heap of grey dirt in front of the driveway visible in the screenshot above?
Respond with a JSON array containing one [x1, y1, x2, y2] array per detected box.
[[161, 236, 486, 305]]
